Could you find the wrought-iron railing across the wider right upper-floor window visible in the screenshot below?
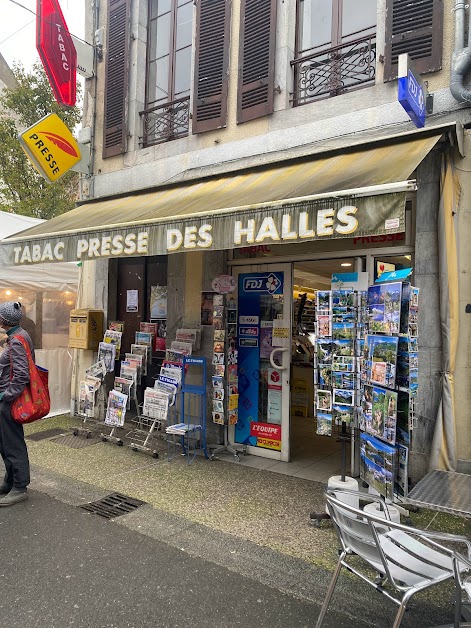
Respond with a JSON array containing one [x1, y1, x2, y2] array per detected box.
[[291, 35, 376, 106]]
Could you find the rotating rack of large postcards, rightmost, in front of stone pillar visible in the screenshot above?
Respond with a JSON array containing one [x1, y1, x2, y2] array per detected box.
[[358, 282, 418, 500]]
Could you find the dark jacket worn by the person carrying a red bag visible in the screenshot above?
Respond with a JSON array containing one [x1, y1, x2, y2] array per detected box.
[[0, 327, 35, 402]]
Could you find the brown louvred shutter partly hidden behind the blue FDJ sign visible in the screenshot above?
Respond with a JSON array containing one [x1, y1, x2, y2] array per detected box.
[[384, 0, 443, 81]]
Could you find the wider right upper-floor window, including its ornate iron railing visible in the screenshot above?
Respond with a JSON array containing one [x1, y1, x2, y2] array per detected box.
[[292, 0, 377, 106]]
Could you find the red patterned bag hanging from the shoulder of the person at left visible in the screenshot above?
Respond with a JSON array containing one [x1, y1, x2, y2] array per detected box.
[[10, 336, 51, 423]]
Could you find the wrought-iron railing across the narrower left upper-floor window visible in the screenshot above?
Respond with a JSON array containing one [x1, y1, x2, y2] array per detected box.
[[139, 96, 190, 146]]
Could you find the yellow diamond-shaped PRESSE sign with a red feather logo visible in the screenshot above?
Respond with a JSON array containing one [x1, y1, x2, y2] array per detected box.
[[18, 113, 81, 183]]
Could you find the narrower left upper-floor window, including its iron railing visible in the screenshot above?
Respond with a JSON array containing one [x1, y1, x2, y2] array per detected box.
[[141, 0, 194, 146]]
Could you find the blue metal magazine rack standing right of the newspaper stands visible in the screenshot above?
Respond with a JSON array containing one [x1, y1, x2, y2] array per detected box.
[[165, 356, 208, 464]]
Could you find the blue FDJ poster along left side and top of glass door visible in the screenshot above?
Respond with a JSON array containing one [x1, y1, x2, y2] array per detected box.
[[235, 272, 283, 446]]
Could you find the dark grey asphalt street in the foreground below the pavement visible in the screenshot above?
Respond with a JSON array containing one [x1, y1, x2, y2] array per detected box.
[[0, 490, 366, 628]]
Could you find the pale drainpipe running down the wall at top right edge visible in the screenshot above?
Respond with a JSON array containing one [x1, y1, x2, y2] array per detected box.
[[450, 0, 471, 104]]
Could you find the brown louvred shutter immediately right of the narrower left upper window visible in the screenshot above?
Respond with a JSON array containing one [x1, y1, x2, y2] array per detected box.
[[192, 0, 231, 133]]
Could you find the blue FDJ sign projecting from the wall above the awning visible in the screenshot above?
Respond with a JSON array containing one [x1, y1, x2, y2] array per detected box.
[[397, 54, 427, 129]]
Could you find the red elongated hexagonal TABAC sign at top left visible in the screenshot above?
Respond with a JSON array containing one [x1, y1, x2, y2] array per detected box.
[[36, 0, 77, 107]]
